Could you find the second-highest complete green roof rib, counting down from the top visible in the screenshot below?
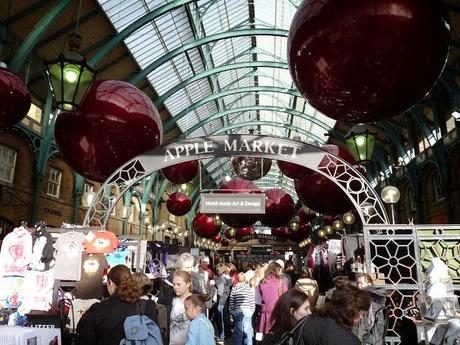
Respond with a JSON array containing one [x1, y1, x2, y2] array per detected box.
[[153, 61, 288, 107]]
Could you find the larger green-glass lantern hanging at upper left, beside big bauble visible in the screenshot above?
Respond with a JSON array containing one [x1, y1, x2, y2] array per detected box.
[[46, 34, 96, 111]]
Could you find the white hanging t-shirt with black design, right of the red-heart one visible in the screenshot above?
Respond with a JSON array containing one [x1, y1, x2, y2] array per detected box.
[[29, 229, 54, 271]]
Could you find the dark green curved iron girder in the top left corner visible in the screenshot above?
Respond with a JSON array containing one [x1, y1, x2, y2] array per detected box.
[[9, 0, 72, 73]]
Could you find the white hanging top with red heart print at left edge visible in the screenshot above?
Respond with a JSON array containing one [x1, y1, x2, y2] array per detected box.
[[0, 226, 32, 277]]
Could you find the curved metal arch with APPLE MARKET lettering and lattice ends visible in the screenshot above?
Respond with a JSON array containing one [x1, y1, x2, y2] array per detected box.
[[83, 135, 388, 227]]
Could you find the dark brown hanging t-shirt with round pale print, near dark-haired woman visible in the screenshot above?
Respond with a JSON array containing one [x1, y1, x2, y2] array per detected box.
[[74, 254, 108, 299]]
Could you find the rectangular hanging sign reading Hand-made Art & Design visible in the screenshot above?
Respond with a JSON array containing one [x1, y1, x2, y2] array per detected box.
[[200, 193, 265, 214]]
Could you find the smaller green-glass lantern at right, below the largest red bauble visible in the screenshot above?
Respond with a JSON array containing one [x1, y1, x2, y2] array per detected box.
[[344, 124, 375, 163]]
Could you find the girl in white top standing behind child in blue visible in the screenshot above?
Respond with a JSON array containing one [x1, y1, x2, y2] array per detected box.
[[169, 271, 192, 345]]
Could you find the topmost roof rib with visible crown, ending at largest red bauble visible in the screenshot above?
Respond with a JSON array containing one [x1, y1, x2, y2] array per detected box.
[[128, 29, 289, 85]]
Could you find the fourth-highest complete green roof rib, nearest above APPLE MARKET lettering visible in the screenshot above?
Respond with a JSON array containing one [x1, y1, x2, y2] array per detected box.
[[187, 105, 332, 135]]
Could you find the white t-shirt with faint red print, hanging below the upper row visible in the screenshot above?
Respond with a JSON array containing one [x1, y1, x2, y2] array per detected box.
[[23, 270, 54, 310]]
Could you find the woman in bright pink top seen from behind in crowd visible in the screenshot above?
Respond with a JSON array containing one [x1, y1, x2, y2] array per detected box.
[[257, 261, 287, 334]]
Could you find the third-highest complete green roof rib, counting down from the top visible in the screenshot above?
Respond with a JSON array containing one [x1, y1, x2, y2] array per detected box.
[[163, 86, 301, 133]]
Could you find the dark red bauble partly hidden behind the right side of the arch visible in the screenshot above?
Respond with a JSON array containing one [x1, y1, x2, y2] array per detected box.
[[295, 145, 356, 214]]
